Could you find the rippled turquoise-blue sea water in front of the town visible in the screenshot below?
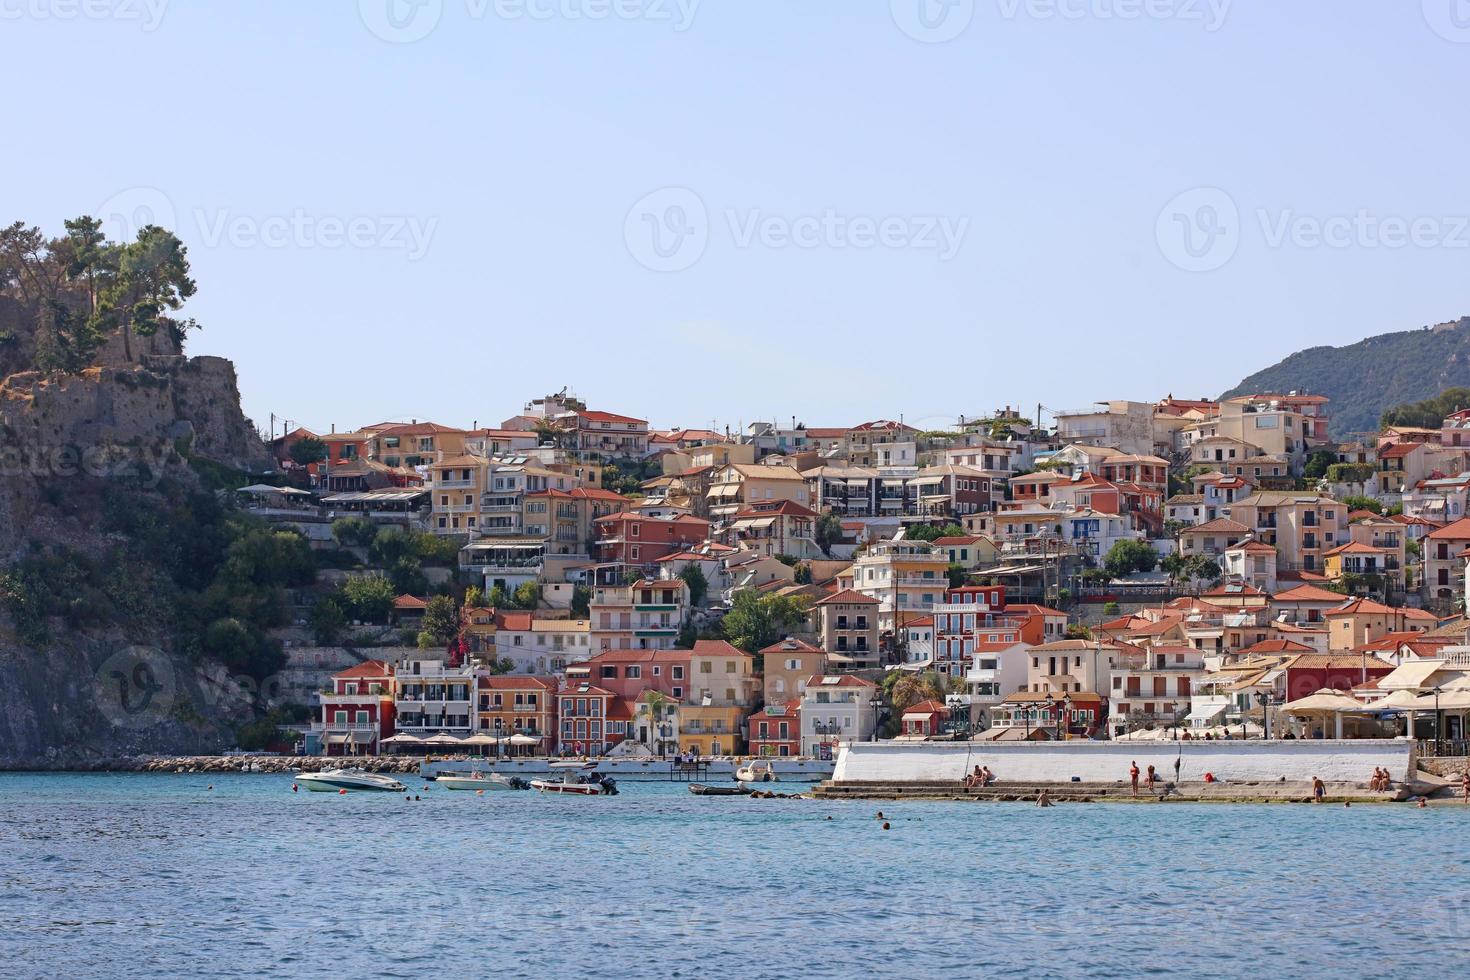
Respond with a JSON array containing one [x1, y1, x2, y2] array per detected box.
[[0, 774, 1470, 977]]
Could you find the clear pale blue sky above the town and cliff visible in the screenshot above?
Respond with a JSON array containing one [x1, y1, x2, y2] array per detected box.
[[0, 0, 1470, 429]]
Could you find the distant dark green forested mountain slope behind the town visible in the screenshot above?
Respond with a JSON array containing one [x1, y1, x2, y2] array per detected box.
[[1222, 316, 1470, 439]]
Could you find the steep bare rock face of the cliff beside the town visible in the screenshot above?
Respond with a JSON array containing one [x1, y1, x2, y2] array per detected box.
[[0, 348, 268, 768]]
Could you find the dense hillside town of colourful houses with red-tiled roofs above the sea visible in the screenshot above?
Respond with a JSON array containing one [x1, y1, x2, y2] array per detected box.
[[238, 391, 1470, 760]]
